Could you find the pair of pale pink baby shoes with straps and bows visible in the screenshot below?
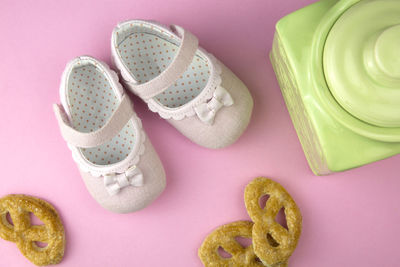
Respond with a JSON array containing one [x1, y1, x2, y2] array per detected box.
[[54, 20, 253, 213]]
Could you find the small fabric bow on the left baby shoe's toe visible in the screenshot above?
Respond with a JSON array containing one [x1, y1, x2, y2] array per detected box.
[[104, 165, 143, 196]]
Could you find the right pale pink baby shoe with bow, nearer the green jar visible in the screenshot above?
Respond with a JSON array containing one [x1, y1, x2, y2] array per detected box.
[[111, 20, 253, 148]]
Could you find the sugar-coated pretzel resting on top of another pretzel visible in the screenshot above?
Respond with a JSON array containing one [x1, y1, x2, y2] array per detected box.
[[244, 177, 302, 267]]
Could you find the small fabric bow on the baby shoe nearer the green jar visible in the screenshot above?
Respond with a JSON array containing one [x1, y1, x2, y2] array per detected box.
[[194, 86, 233, 125]]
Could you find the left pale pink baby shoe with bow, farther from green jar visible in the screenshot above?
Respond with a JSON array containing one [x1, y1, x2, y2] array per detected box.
[[54, 56, 166, 213]]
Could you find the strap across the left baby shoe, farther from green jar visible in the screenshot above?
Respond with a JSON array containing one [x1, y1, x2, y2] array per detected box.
[[53, 95, 134, 148]]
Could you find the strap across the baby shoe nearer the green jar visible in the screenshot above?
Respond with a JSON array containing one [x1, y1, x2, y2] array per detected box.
[[130, 25, 199, 100]]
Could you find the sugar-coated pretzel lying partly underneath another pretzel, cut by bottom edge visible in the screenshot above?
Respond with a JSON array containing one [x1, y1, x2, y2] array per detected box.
[[198, 221, 264, 267]]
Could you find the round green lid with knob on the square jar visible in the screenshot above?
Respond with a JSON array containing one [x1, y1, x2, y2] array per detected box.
[[322, 0, 400, 130]]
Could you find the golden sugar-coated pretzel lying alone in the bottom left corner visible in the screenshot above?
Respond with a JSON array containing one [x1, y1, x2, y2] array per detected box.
[[0, 195, 65, 266]]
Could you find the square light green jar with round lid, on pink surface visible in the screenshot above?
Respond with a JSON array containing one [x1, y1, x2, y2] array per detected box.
[[271, 0, 400, 175]]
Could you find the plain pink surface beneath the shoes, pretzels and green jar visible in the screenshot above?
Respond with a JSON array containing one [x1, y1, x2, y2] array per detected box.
[[0, 0, 400, 267]]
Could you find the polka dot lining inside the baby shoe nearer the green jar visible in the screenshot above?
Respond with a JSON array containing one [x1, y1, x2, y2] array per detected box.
[[118, 30, 210, 108]]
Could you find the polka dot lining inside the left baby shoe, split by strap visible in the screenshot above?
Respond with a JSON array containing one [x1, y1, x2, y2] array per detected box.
[[67, 64, 135, 165]]
